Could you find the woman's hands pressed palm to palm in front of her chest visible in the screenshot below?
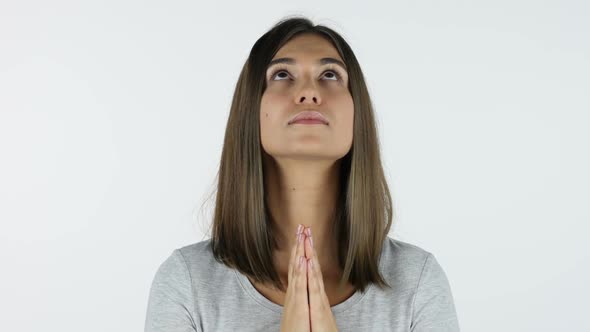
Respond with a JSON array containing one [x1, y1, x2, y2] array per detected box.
[[281, 225, 338, 332]]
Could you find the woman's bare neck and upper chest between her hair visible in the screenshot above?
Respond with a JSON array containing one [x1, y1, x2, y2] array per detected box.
[[265, 152, 340, 280]]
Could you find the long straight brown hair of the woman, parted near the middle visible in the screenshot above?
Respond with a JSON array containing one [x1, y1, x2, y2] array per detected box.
[[211, 17, 392, 291]]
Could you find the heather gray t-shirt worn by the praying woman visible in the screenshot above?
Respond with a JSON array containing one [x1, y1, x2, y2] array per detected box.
[[145, 237, 459, 332]]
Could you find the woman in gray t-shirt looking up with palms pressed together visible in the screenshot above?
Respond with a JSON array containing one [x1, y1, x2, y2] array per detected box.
[[145, 18, 459, 331]]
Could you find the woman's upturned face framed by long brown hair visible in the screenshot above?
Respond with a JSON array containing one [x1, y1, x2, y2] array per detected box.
[[260, 34, 354, 160]]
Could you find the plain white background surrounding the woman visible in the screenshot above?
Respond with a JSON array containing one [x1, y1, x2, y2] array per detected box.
[[0, 0, 590, 331]]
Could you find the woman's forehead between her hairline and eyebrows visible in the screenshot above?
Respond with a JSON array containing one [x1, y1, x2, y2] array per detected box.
[[274, 34, 342, 61]]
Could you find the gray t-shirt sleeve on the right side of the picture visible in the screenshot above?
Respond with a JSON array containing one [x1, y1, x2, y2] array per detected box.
[[410, 253, 459, 332]]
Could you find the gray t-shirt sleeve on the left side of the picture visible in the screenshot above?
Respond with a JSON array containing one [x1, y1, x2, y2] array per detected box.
[[144, 249, 198, 332]]
